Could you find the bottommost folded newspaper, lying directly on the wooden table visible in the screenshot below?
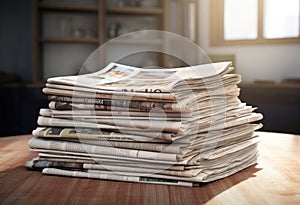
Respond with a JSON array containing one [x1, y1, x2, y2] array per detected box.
[[43, 146, 257, 186]]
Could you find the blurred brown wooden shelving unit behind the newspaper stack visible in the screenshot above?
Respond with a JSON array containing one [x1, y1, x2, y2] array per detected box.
[[32, 0, 196, 84]]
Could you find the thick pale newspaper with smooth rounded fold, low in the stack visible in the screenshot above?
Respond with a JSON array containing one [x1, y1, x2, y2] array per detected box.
[[29, 133, 257, 165]]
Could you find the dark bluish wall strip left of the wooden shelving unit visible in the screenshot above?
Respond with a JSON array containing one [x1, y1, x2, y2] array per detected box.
[[0, 0, 32, 82]]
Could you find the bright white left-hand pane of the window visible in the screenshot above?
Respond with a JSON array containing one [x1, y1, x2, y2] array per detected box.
[[224, 0, 258, 40]]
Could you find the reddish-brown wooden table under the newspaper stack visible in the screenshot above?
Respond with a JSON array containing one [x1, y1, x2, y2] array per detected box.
[[0, 132, 300, 205]]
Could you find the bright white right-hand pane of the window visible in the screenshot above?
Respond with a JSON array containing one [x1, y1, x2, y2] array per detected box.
[[263, 0, 299, 39]]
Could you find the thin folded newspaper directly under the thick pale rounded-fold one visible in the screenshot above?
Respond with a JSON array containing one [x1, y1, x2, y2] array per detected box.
[[29, 135, 257, 171]]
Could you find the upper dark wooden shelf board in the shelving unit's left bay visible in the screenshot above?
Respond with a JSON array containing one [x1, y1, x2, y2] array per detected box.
[[38, 2, 98, 12]]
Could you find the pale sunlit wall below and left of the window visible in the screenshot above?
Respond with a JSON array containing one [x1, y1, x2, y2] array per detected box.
[[199, 0, 300, 82]]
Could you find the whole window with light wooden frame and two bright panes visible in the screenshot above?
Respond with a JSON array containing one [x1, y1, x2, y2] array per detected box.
[[210, 0, 300, 45]]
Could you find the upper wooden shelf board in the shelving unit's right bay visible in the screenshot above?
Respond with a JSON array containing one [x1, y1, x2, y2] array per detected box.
[[106, 7, 163, 15]]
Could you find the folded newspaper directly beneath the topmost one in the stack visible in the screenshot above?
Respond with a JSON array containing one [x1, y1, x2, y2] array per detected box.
[[43, 75, 240, 105]]
